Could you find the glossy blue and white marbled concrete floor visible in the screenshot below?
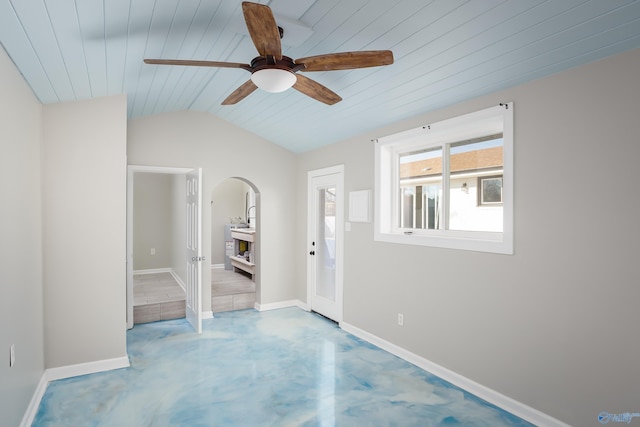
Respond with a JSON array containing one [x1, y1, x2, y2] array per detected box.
[[33, 308, 531, 427]]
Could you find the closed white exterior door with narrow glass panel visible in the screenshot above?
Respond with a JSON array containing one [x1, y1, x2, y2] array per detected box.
[[307, 166, 344, 323]]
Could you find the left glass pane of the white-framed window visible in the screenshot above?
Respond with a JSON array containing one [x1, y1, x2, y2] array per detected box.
[[398, 147, 442, 229]]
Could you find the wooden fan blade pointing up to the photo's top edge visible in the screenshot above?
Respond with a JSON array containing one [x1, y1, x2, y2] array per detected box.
[[242, 1, 282, 60]]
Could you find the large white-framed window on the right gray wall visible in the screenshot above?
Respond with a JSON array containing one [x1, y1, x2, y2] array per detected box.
[[374, 103, 513, 254]]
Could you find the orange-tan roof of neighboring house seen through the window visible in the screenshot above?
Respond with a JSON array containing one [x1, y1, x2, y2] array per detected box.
[[400, 147, 503, 179]]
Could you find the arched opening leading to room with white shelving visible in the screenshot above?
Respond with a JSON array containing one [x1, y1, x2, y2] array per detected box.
[[211, 177, 261, 317]]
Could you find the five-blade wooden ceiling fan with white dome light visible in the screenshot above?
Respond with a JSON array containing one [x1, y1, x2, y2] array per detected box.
[[144, 2, 393, 105]]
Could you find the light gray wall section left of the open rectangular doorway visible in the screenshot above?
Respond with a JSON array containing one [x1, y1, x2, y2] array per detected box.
[[42, 96, 127, 368]]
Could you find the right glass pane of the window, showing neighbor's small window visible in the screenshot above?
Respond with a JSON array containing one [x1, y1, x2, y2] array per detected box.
[[449, 136, 503, 232]]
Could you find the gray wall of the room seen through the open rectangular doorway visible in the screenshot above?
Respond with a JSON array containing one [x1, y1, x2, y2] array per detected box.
[[133, 172, 174, 271]]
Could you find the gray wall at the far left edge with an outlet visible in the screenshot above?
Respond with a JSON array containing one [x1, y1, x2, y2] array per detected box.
[[0, 48, 44, 426]]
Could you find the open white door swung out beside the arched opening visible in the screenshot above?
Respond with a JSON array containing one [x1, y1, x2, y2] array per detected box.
[[185, 169, 204, 333]]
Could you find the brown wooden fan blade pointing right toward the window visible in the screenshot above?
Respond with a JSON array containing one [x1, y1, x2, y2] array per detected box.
[[295, 50, 393, 71]]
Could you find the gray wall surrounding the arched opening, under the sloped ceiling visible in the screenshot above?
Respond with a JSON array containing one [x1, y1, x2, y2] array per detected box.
[[127, 111, 296, 311]]
